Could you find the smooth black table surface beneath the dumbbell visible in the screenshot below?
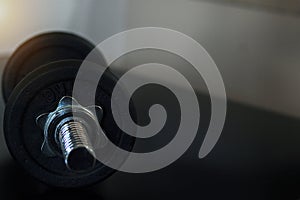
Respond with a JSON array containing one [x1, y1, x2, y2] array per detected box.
[[0, 93, 300, 200]]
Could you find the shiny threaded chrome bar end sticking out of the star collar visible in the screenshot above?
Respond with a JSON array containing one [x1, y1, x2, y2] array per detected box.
[[59, 121, 95, 171]]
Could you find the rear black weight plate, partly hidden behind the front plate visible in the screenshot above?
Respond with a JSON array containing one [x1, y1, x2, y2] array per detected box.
[[2, 32, 94, 102]]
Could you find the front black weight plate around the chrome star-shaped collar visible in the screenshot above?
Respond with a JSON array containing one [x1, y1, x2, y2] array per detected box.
[[4, 60, 134, 187]]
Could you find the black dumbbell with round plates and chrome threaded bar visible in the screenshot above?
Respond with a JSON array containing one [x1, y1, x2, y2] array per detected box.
[[2, 32, 134, 188]]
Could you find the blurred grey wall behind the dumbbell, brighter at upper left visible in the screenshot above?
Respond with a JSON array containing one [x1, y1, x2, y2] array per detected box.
[[0, 0, 300, 117]]
